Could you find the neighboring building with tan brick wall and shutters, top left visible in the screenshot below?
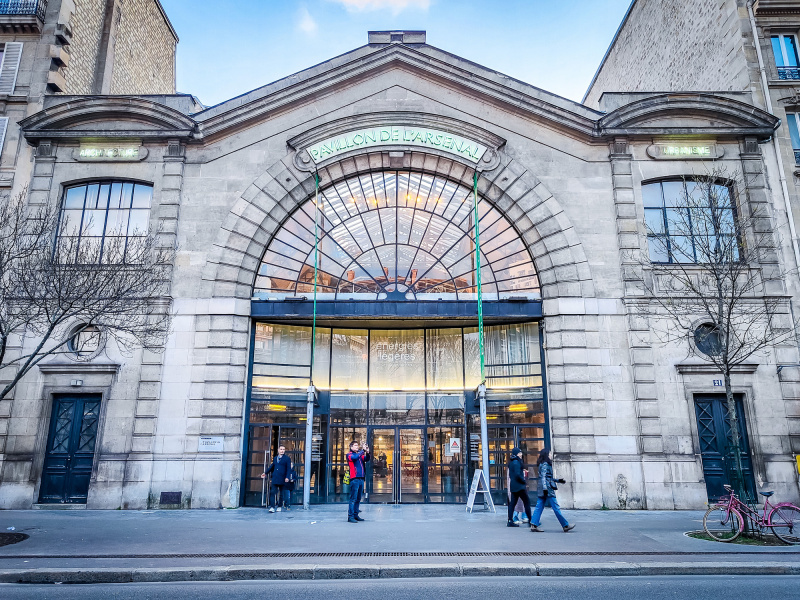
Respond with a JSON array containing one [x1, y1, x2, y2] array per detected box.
[[0, 0, 178, 193]]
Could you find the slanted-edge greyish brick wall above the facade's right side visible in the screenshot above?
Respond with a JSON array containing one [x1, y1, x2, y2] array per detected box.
[[585, 0, 750, 107]]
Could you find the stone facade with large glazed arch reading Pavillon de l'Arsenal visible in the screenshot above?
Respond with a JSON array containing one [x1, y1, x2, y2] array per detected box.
[[0, 24, 800, 509]]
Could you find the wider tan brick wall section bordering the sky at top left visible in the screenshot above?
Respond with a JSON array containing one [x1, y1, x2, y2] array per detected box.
[[110, 0, 176, 94]]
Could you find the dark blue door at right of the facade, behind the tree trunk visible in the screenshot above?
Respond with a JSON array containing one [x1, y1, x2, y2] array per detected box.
[[695, 394, 755, 502]]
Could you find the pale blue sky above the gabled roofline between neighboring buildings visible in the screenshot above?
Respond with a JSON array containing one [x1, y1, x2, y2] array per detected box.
[[161, 0, 630, 105]]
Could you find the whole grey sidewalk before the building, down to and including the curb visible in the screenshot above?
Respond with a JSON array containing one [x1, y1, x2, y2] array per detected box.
[[0, 505, 800, 581]]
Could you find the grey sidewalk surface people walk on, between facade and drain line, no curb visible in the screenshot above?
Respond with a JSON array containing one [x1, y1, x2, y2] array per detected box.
[[0, 505, 800, 556]]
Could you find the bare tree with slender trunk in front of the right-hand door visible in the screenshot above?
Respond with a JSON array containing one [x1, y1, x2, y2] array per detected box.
[[633, 167, 796, 496]]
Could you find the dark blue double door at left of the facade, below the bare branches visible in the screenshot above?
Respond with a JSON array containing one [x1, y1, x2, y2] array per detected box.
[[39, 395, 100, 504]]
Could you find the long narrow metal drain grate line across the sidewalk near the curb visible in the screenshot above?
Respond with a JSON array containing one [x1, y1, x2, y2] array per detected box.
[[0, 552, 800, 559]]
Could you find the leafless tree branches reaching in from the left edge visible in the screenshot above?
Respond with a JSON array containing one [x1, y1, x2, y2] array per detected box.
[[0, 190, 175, 399]]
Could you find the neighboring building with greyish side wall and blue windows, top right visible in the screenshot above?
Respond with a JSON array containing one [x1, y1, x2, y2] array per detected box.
[[583, 0, 800, 278]]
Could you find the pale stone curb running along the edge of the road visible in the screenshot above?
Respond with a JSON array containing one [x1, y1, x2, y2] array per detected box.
[[0, 562, 800, 584]]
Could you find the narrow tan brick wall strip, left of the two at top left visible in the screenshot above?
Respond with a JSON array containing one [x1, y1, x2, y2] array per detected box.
[[64, 0, 106, 94]]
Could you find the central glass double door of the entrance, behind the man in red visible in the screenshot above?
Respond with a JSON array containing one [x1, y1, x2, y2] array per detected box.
[[368, 427, 427, 504]]
